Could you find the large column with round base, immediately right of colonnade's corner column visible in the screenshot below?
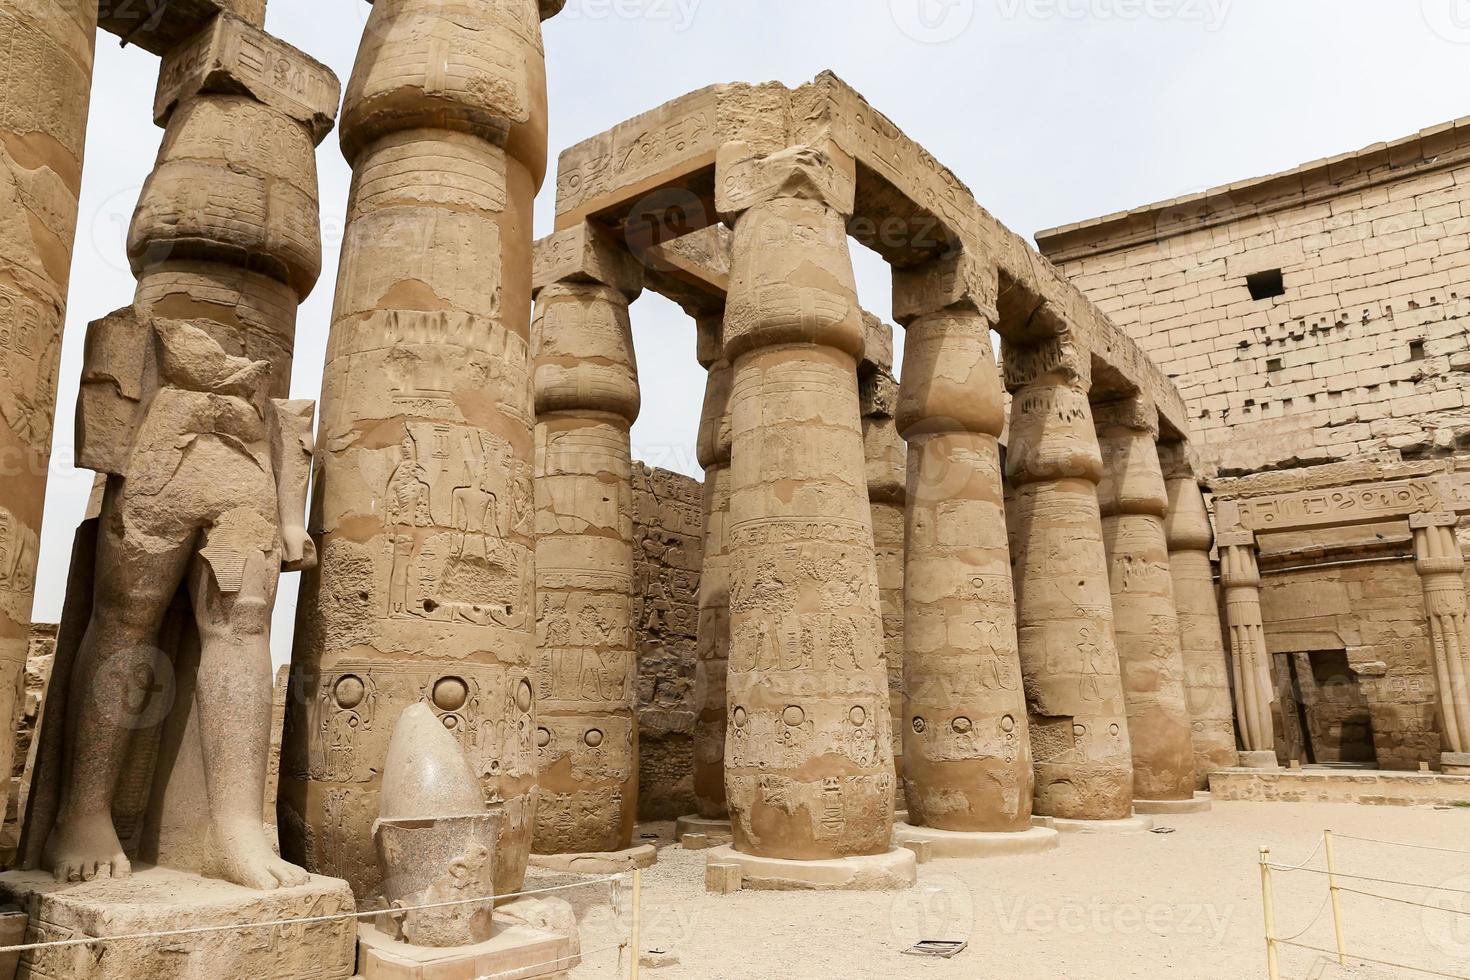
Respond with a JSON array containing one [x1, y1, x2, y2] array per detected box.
[[894, 253, 1057, 857]]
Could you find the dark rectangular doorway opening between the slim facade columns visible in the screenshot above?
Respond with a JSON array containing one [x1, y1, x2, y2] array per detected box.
[[1273, 649, 1377, 767]]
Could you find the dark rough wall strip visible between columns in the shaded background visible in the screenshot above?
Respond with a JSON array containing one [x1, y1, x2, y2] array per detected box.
[[634, 463, 704, 820]]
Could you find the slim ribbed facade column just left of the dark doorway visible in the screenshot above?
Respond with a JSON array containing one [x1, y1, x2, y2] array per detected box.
[[1214, 530, 1280, 768]]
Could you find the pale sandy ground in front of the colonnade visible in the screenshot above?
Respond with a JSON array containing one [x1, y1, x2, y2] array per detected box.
[[528, 802, 1470, 980]]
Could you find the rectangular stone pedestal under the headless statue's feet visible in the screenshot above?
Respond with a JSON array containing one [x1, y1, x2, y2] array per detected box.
[[0, 868, 357, 980]]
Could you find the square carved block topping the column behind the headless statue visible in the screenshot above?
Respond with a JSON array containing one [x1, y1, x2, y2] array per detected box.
[[153, 13, 343, 145]]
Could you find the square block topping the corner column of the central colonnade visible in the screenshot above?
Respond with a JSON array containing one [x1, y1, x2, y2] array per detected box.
[[714, 141, 857, 222]]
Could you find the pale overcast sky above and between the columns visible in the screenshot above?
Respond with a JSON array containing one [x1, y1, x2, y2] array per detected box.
[[35, 0, 1470, 657]]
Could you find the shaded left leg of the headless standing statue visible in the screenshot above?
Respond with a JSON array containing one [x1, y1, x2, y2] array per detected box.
[[43, 478, 194, 882]]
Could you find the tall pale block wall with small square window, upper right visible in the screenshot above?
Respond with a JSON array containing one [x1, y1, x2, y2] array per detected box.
[[1038, 125, 1470, 475]]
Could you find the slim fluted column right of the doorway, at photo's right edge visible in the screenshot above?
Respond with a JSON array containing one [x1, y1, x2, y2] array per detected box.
[[1408, 514, 1470, 776]]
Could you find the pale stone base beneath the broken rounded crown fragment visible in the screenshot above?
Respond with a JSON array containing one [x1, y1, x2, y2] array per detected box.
[[357, 899, 581, 980]]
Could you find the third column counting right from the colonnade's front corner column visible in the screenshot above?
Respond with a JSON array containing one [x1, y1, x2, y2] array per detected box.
[[1003, 332, 1133, 821]]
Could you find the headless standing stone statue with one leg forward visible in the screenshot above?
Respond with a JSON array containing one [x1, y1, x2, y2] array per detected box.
[[43, 307, 316, 889]]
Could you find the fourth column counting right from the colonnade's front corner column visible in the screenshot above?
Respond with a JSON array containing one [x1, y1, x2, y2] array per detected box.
[[1092, 395, 1194, 811]]
